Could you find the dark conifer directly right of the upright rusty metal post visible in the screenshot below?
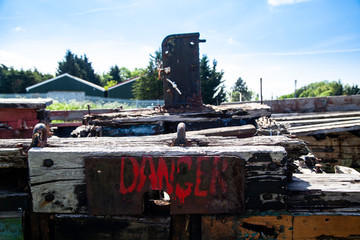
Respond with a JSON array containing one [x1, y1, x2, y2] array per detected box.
[[200, 55, 226, 105]]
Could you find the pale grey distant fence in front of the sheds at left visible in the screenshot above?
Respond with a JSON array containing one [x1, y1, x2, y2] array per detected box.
[[0, 93, 164, 108]]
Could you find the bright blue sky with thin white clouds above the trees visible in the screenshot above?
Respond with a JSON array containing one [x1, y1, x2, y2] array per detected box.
[[0, 0, 360, 99]]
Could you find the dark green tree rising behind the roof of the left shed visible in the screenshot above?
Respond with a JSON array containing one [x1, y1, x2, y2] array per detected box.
[[56, 50, 100, 85]]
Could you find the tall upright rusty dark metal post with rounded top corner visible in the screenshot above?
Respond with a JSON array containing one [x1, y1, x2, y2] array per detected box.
[[159, 33, 205, 109]]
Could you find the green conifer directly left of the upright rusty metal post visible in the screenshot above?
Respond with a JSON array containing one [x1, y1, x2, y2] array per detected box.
[[133, 50, 163, 100]]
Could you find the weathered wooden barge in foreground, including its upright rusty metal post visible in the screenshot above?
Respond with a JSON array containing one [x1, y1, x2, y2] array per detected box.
[[0, 34, 360, 240]]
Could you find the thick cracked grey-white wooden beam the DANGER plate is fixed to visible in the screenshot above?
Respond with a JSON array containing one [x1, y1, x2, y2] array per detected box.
[[28, 145, 286, 213]]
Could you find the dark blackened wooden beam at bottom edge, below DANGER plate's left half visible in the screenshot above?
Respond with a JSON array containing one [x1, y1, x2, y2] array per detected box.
[[52, 214, 171, 240]]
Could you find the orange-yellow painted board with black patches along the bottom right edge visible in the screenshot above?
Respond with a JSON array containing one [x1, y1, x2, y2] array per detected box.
[[202, 214, 360, 240]]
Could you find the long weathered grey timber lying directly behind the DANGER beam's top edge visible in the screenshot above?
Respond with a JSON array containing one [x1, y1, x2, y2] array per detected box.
[[0, 135, 305, 154]]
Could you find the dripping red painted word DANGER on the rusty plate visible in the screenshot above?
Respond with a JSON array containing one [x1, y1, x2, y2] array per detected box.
[[119, 156, 229, 203]]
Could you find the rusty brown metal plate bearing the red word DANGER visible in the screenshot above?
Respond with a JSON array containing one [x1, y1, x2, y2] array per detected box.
[[85, 156, 245, 215]]
